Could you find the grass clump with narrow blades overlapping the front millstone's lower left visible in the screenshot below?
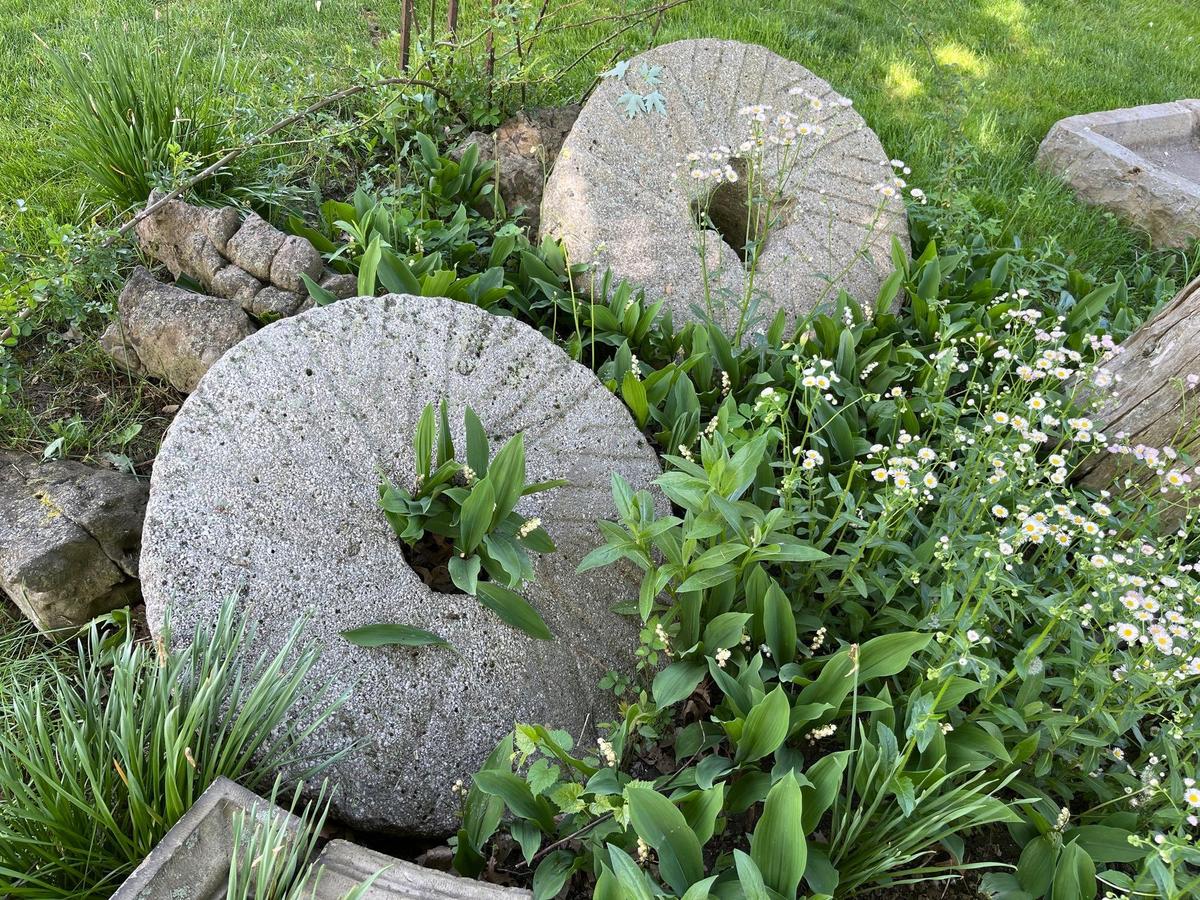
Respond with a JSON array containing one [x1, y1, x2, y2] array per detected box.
[[0, 601, 342, 900]]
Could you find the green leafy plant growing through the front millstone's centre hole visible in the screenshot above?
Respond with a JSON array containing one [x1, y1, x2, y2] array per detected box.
[[344, 401, 566, 646]]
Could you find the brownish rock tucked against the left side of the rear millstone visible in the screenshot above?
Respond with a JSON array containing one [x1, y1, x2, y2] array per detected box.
[[455, 103, 581, 233]]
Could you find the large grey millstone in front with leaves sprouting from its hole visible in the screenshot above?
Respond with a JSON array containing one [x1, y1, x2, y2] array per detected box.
[[142, 295, 659, 834]]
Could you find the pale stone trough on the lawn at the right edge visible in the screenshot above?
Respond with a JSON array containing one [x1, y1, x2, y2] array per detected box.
[[1037, 100, 1200, 247]]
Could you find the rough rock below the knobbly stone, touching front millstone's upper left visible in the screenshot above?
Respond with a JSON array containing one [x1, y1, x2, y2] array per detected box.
[[101, 266, 254, 394]]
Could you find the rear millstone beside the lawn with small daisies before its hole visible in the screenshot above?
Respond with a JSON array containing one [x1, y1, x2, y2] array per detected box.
[[541, 40, 908, 331]]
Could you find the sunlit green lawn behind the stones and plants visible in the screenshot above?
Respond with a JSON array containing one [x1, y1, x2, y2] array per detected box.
[[7, 0, 1200, 271]]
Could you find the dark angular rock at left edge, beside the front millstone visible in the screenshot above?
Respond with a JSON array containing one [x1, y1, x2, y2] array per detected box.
[[0, 451, 146, 631]]
